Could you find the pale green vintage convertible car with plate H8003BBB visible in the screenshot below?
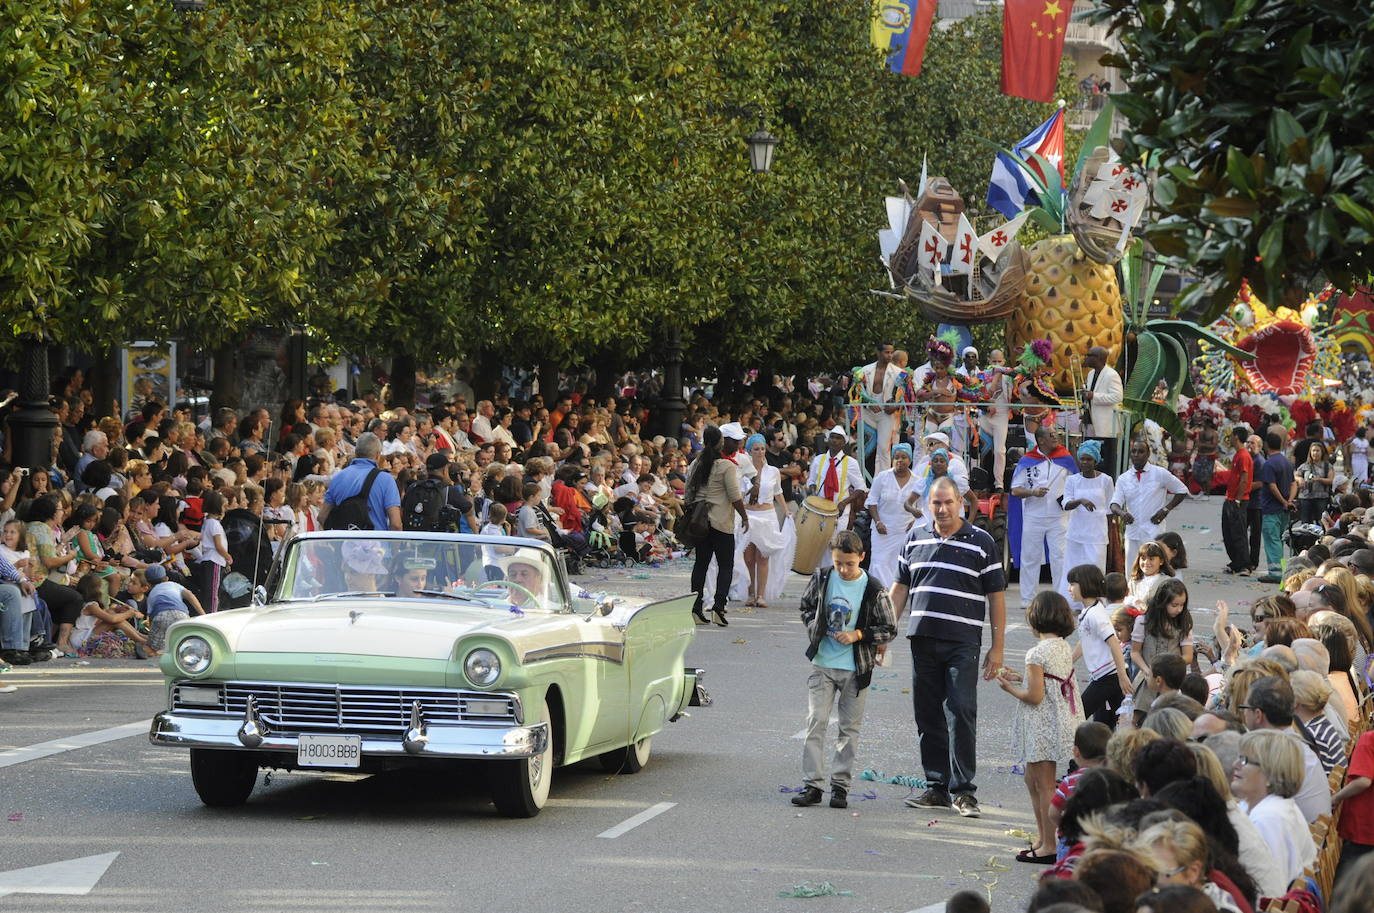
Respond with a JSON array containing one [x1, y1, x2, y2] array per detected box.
[[148, 531, 710, 817]]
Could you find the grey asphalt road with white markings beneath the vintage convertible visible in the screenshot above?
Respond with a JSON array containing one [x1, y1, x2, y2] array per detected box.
[[0, 498, 1264, 913]]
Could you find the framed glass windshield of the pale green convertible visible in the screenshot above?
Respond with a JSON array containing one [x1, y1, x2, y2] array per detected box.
[[271, 536, 567, 612]]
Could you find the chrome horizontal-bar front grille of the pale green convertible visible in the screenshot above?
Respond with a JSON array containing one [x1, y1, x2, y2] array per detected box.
[[172, 682, 519, 734]]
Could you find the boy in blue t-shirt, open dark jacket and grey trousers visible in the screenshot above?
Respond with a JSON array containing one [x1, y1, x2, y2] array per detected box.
[[791, 529, 897, 809]]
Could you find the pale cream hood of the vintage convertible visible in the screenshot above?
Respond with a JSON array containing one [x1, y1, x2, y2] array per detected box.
[[217, 601, 555, 660]]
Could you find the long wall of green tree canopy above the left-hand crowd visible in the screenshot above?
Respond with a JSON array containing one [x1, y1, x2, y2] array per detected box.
[[0, 0, 1069, 370]]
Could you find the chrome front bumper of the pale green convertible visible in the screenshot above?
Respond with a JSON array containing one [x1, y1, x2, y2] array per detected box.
[[148, 710, 548, 760]]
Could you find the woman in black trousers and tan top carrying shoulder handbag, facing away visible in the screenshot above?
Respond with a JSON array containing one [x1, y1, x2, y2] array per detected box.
[[686, 425, 749, 627]]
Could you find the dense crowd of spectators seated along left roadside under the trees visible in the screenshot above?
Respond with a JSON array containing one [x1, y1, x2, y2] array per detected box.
[[0, 370, 857, 690]]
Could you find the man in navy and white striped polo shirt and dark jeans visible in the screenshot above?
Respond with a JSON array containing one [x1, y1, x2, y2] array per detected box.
[[892, 476, 1007, 818]]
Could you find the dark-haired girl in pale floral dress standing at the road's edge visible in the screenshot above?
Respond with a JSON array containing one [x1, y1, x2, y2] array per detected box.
[[998, 590, 1083, 865]]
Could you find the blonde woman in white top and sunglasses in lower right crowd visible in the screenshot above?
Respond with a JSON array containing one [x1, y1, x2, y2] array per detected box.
[[1231, 729, 1316, 883]]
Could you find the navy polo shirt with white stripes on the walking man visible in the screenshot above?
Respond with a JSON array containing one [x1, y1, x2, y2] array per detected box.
[[897, 520, 1007, 644]]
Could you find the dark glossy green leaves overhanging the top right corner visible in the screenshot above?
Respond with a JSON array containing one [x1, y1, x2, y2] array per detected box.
[[1090, 0, 1374, 322]]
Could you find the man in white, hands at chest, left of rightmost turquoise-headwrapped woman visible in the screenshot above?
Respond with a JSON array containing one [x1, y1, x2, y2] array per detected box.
[[1011, 425, 1069, 606]]
